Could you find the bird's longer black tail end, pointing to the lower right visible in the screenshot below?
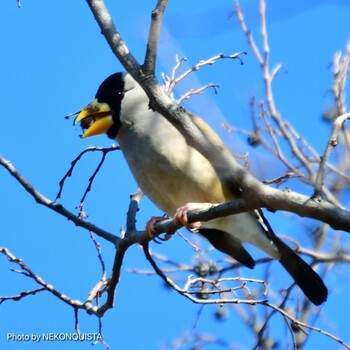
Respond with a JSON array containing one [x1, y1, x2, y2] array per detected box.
[[273, 236, 328, 305]]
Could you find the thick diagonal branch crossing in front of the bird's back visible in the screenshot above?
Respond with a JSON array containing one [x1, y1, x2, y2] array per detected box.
[[88, 0, 350, 231]]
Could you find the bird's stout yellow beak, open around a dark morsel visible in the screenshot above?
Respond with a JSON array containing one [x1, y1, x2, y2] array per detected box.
[[74, 100, 114, 138]]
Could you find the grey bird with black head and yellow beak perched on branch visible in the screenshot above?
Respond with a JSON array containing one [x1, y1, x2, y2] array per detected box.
[[74, 72, 328, 305]]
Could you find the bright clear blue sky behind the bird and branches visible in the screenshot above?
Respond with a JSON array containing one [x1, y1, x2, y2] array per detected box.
[[0, 0, 350, 350]]
